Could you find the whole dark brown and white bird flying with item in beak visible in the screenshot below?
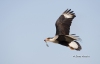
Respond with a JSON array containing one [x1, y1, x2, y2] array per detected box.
[[44, 9, 82, 51]]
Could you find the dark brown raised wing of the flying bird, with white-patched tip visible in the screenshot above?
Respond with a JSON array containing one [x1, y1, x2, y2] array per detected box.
[[55, 9, 76, 35]]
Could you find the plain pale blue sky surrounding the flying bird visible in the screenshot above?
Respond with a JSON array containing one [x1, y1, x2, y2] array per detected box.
[[0, 0, 100, 64]]
